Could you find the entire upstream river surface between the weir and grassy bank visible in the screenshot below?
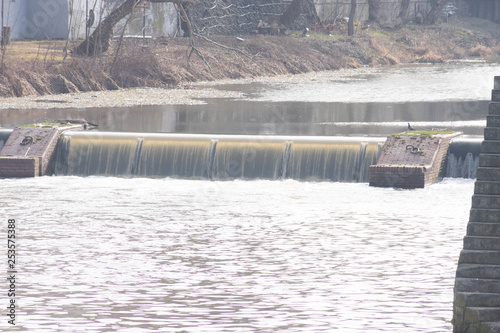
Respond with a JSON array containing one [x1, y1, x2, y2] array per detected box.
[[0, 63, 494, 136]]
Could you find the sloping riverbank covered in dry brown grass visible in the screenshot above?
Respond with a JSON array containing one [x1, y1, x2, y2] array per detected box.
[[0, 19, 500, 97]]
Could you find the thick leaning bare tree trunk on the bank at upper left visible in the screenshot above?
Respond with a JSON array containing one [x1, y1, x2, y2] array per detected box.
[[74, 0, 140, 56]]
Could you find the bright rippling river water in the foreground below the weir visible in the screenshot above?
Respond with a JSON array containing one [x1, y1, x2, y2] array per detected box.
[[0, 177, 473, 333]]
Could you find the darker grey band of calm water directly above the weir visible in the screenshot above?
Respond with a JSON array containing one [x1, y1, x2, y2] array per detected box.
[[0, 99, 489, 136]]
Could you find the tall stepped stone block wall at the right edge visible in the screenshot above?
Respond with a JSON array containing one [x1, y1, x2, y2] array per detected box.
[[453, 76, 500, 333]]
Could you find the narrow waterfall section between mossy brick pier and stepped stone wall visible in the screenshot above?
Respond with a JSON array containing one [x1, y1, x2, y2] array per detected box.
[[446, 138, 483, 178]]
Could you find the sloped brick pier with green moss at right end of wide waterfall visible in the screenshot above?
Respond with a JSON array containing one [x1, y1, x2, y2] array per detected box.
[[370, 132, 462, 188]]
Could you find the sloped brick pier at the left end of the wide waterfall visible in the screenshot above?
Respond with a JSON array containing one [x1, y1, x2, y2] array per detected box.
[[0, 125, 83, 178]]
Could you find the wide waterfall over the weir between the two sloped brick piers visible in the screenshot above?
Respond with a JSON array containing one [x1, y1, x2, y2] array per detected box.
[[55, 131, 385, 182]]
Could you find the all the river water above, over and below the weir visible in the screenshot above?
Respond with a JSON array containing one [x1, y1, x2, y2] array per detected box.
[[0, 63, 500, 333]]
